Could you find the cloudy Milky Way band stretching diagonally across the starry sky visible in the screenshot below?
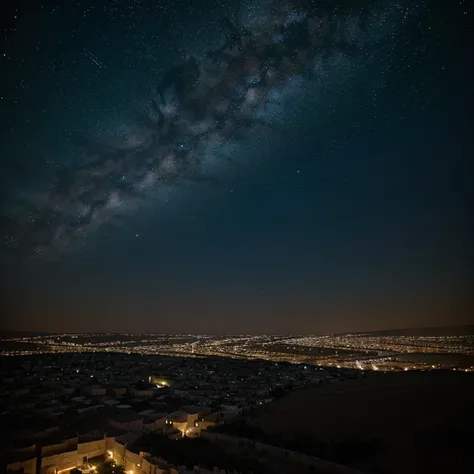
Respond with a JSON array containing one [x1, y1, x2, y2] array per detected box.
[[2, 2, 409, 259]]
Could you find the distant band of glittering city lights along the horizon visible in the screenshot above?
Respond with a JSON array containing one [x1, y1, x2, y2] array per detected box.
[[0, 333, 474, 372]]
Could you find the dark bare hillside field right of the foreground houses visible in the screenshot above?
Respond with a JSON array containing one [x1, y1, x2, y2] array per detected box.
[[253, 372, 474, 474]]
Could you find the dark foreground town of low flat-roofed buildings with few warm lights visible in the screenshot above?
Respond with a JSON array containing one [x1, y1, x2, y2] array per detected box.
[[0, 353, 358, 474]]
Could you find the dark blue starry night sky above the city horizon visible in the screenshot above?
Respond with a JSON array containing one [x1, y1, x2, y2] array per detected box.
[[0, 0, 474, 334]]
